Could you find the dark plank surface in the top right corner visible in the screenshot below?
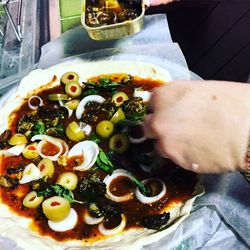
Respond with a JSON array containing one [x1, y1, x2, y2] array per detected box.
[[148, 0, 250, 82]]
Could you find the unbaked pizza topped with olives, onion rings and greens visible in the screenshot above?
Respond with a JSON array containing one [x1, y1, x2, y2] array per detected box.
[[0, 61, 202, 250]]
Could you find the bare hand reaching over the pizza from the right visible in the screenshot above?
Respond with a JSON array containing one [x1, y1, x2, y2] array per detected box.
[[145, 81, 250, 173]]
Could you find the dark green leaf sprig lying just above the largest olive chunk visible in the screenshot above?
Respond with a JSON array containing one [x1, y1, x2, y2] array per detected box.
[[37, 184, 84, 204]]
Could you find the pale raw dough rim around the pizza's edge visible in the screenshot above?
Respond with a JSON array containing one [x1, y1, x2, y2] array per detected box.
[[0, 60, 203, 250]]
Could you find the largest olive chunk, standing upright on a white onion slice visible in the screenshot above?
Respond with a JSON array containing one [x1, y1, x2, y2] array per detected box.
[[42, 196, 70, 221]]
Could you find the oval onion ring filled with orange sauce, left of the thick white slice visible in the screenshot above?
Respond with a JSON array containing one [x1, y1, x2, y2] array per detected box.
[[31, 135, 63, 161]]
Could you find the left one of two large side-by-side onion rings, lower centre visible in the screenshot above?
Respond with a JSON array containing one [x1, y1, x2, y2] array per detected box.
[[103, 168, 134, 202]]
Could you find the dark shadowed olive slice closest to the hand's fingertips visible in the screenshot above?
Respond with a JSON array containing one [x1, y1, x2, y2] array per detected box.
[[109, 134, 129, 154]]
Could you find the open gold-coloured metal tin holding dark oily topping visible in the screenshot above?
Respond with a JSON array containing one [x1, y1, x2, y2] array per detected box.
[[81, 0, 145, 40]]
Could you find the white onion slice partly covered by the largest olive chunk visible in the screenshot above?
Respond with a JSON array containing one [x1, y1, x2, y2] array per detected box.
[[48, 208, 78, 232]]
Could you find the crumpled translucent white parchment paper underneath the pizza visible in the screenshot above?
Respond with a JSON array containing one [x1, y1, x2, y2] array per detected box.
[[0, 15, 250, 250]]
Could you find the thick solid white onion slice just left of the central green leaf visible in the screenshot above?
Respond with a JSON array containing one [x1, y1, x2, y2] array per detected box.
[[68, 140, 99, 171]]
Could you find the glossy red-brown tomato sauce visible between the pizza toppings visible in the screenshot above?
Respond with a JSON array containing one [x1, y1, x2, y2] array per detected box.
[[0, 74, 197, 242]]
